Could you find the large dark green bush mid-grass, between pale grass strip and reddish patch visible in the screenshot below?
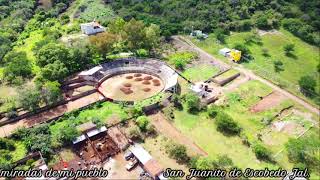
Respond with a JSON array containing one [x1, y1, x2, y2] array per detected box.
[[215, 112, 241, 135]]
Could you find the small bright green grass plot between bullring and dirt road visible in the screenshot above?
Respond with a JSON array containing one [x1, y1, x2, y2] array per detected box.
[[182, 64, 219, 82]]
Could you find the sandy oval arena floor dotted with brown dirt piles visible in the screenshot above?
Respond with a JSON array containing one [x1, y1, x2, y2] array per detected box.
[[99, 73, 164, 101]]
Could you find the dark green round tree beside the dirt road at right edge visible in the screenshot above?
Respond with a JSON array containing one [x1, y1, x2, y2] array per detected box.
[[299, 76, 317, 97]]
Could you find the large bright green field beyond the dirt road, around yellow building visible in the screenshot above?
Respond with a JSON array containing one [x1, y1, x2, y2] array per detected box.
[[192, 29, 320, 106]]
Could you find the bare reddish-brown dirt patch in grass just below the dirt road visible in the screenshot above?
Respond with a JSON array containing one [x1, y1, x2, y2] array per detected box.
[[250, 91, 287, 113]]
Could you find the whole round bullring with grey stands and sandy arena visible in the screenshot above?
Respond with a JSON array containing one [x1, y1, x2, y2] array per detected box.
[[79, 59, 178, 102]]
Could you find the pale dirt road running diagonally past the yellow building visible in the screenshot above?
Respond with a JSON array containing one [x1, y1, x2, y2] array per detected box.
[[173, 36, 320, 115]]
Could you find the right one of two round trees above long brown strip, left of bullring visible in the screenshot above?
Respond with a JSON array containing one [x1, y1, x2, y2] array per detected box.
[[42, 81, 62, 105]]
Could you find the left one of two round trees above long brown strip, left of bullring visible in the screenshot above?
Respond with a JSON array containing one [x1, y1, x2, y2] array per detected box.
[[18, 87, 41, 111]]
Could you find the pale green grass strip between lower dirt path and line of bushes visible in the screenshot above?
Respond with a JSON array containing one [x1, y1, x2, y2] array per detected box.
[[174, 107, 274, 168]]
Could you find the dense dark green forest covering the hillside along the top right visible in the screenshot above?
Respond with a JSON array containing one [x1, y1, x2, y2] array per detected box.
[[111, 0, 320, 46]]
